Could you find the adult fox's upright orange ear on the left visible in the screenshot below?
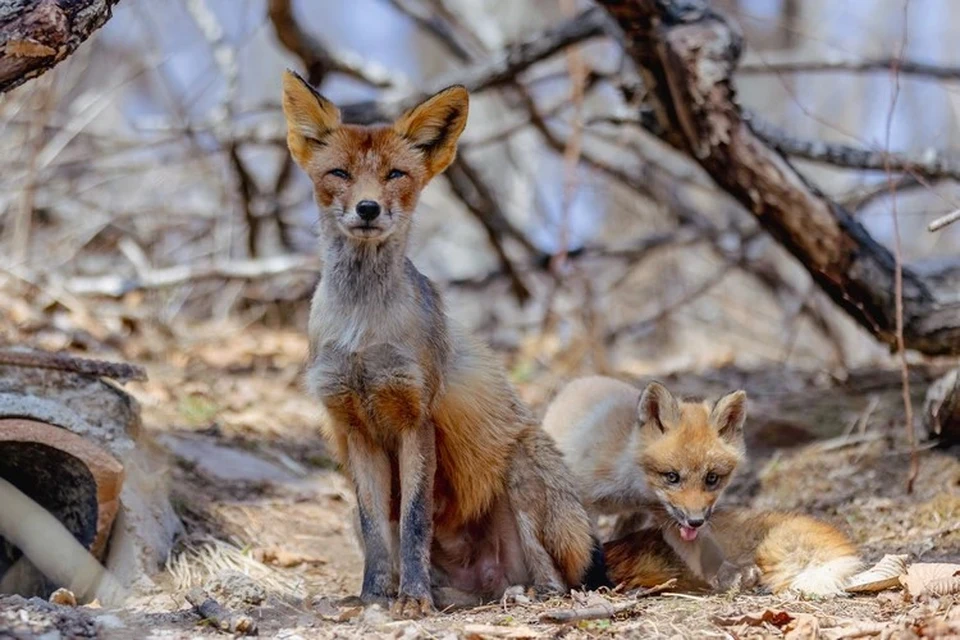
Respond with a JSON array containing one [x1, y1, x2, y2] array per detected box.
[[283, 69, 340, 167]]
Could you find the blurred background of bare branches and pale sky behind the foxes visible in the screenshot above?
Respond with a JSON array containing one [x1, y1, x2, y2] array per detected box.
[[0, 0, 960, 384]]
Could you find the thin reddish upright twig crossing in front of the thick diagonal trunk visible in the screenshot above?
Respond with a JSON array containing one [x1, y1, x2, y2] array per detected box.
[[884, 0, 920, 493]]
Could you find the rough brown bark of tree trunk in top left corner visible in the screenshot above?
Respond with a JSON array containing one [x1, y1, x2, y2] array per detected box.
[[0, 0, 118, 93]]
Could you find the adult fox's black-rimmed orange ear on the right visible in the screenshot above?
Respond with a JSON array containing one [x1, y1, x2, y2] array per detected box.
[[393, 85, 470, 180]]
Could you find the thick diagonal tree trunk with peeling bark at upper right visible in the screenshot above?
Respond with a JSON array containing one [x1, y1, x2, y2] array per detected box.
[[598, 0, 960, 355]]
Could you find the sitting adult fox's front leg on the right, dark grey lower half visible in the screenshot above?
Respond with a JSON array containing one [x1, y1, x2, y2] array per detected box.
[[394, 420, 437, 617]]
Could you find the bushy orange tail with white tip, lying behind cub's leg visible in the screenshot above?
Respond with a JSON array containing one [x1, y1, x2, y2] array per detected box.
[[604, 509, 860, 596]]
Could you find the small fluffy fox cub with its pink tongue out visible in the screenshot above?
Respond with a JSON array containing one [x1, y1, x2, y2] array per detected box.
[[543, 376, 754, 588]]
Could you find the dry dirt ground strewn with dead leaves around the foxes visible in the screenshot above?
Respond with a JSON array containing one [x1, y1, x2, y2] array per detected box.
[[0, 326, 960, 639]]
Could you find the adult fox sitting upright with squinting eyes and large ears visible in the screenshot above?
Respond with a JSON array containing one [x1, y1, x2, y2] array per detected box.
[[283, 71, 605, 615]]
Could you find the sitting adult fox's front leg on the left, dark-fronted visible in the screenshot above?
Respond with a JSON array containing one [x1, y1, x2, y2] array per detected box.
[[347, 433, 396, 606]]
